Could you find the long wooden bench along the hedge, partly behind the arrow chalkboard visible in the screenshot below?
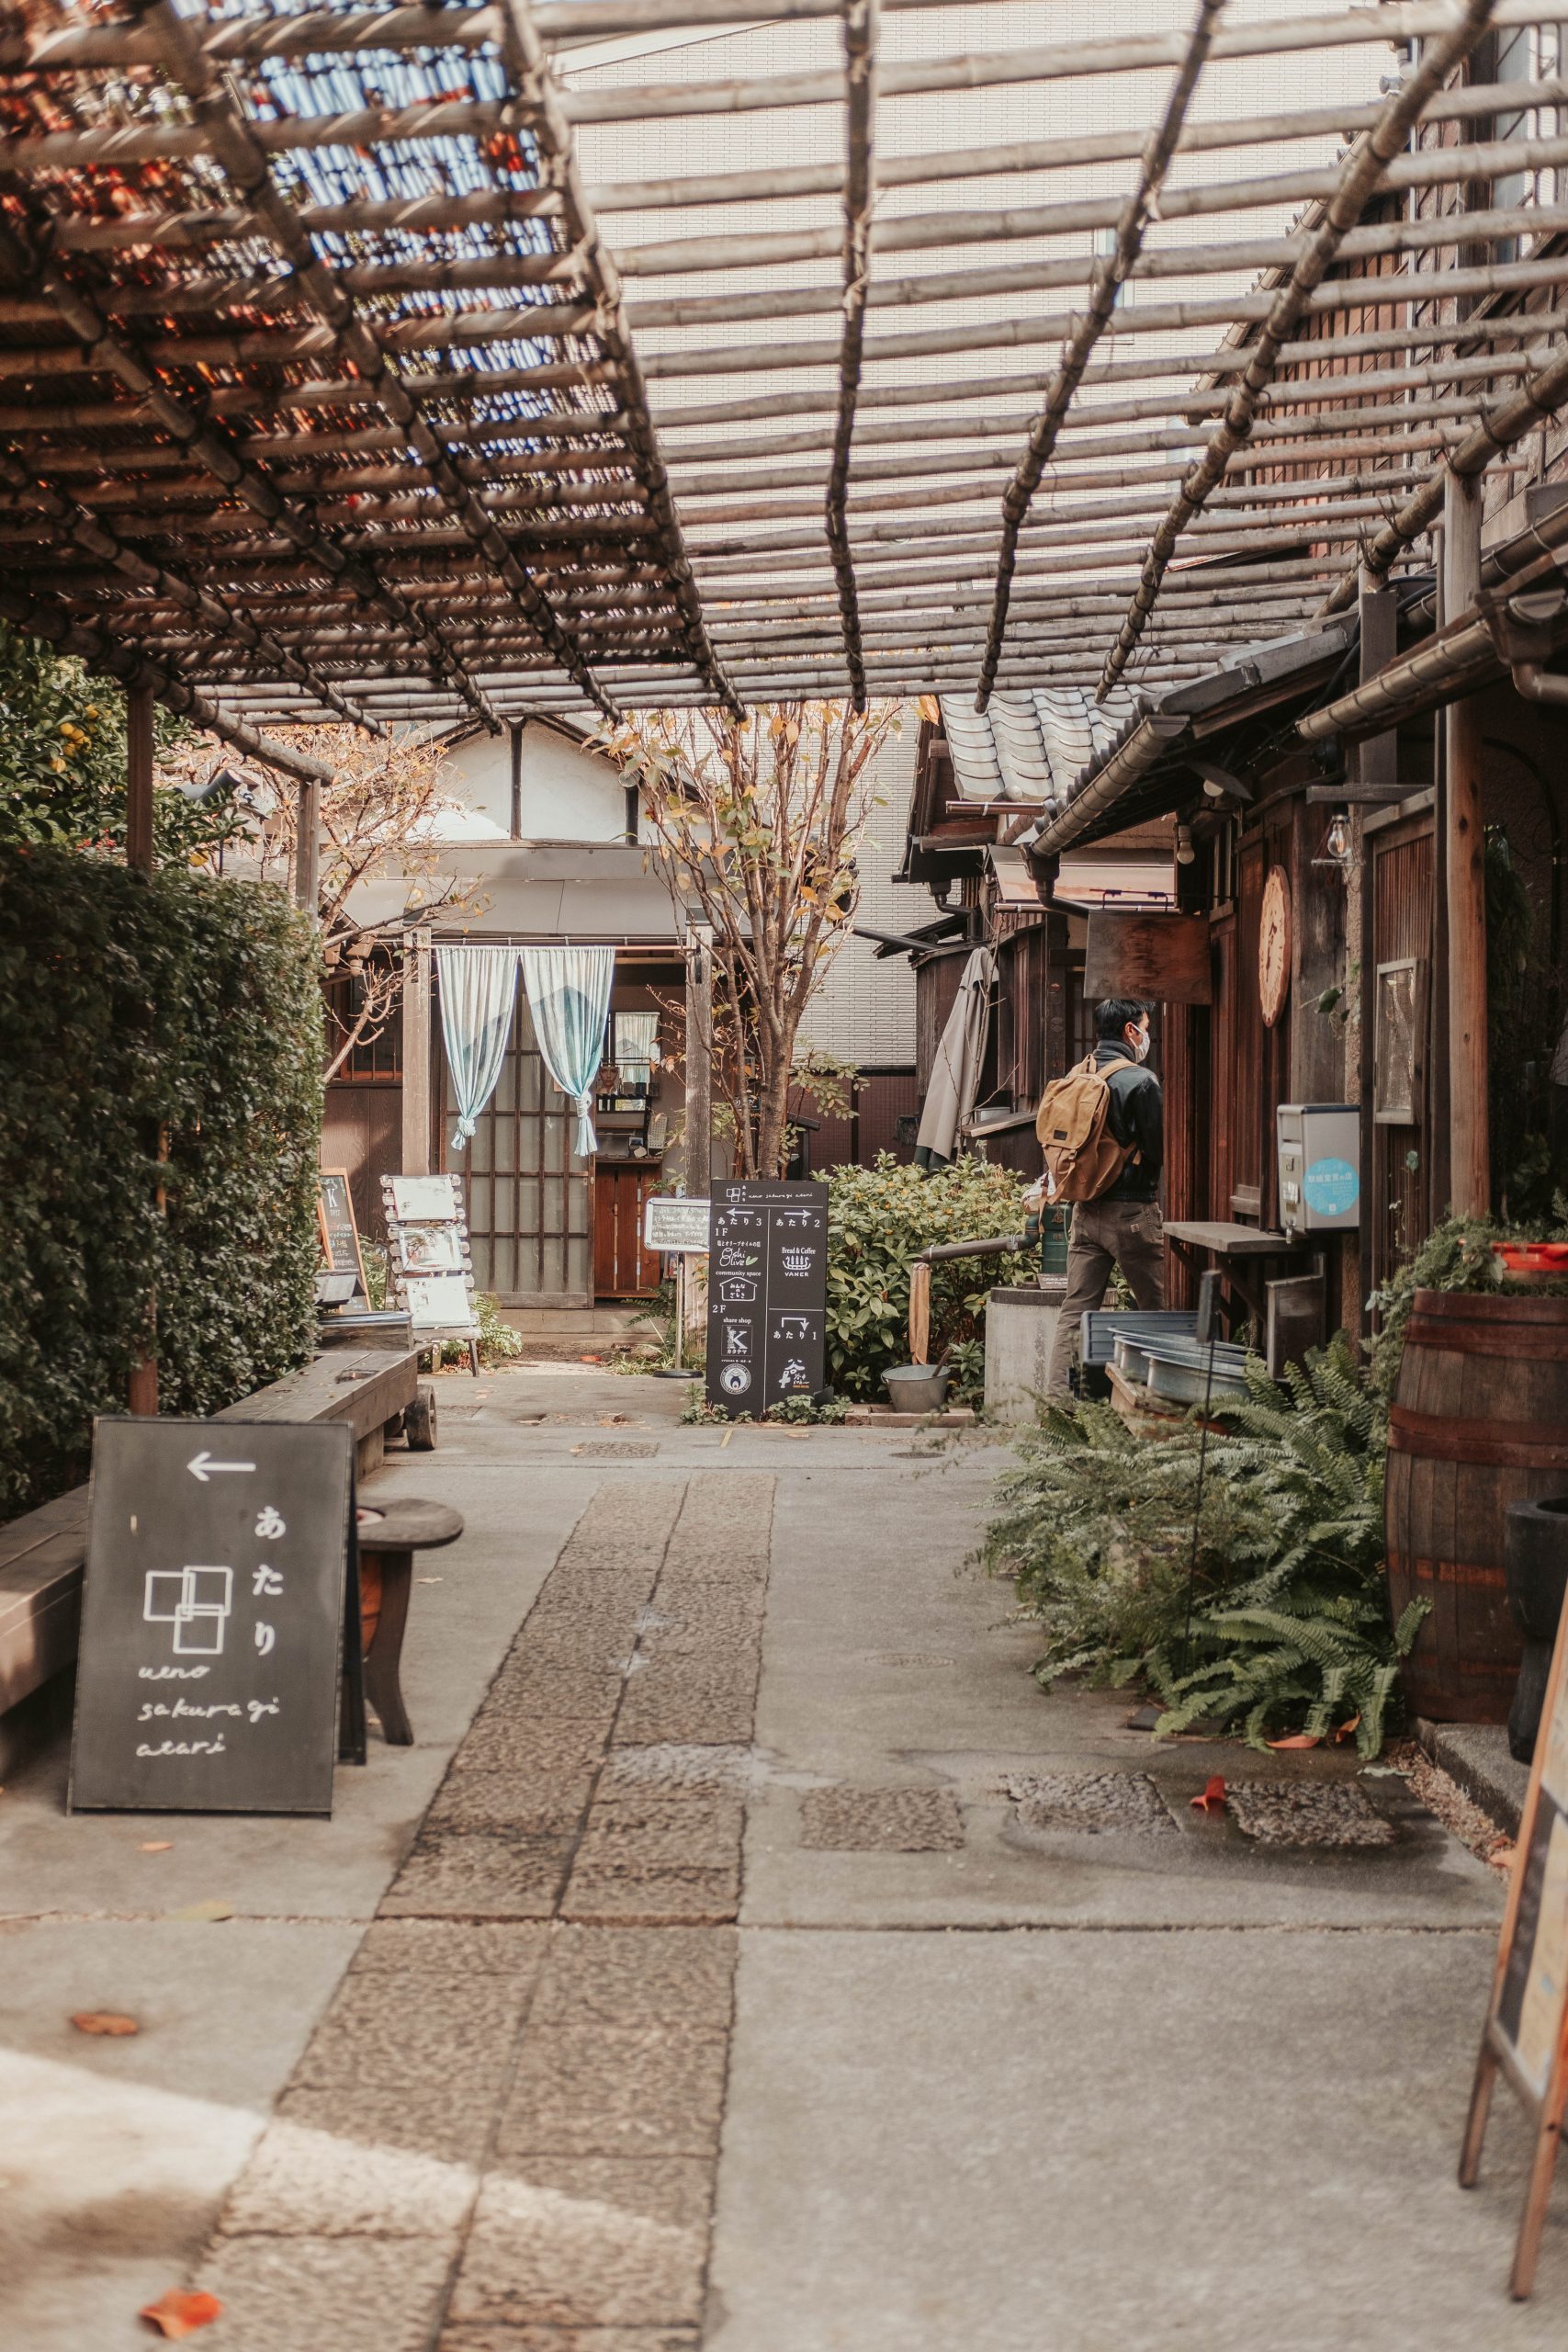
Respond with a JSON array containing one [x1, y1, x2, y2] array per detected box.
[[0, 1348, 434, 1747]]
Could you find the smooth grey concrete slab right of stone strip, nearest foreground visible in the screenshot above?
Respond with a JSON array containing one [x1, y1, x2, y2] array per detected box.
[[705, 1931, 1568, 2352]]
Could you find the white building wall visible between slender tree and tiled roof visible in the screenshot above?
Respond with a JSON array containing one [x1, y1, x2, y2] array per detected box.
[[804, 703, 931, 1070]]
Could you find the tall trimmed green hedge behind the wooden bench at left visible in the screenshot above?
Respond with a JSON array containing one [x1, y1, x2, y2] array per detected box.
[[0, 847, 322, 1517]]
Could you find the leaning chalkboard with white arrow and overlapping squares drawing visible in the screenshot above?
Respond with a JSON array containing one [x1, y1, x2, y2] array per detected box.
[[71, 1420, 353, 1814]]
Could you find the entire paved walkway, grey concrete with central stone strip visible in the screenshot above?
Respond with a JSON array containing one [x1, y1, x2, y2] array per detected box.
[[0, 1369, 1568, 2352]]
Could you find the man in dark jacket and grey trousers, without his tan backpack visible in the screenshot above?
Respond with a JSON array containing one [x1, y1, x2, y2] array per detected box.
[[1046, 997, 1166, 1397]]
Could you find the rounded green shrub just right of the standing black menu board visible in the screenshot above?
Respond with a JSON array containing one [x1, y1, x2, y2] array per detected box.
[[828, 1152, 1025, 1397]]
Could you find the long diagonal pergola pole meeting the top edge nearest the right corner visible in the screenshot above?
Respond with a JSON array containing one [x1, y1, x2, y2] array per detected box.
[[1098, 0, 1495, 701]]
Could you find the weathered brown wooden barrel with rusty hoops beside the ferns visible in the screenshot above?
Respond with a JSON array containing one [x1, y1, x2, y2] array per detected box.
[[1387, 1291, 1568, 1724]]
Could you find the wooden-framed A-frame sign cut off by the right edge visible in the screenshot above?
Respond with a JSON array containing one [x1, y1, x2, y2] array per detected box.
[[1460, 1580, 1568, 2301]]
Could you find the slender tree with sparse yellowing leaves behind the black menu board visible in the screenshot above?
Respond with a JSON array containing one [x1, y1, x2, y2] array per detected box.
[[600, 701, 898, 1176]]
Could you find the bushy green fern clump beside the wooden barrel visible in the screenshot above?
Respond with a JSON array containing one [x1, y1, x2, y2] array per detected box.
[[985, 1336, 1422, 1755]]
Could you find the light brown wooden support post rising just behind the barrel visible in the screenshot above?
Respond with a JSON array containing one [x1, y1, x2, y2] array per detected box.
[[1443, 475, 1491, 1216]]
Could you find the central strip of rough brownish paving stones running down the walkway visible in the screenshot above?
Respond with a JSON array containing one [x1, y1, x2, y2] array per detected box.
[[200, 1473, 773, 2352]]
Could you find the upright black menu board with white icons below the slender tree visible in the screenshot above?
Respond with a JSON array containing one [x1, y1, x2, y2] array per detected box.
[[707, 1183, 828, 1420]]
